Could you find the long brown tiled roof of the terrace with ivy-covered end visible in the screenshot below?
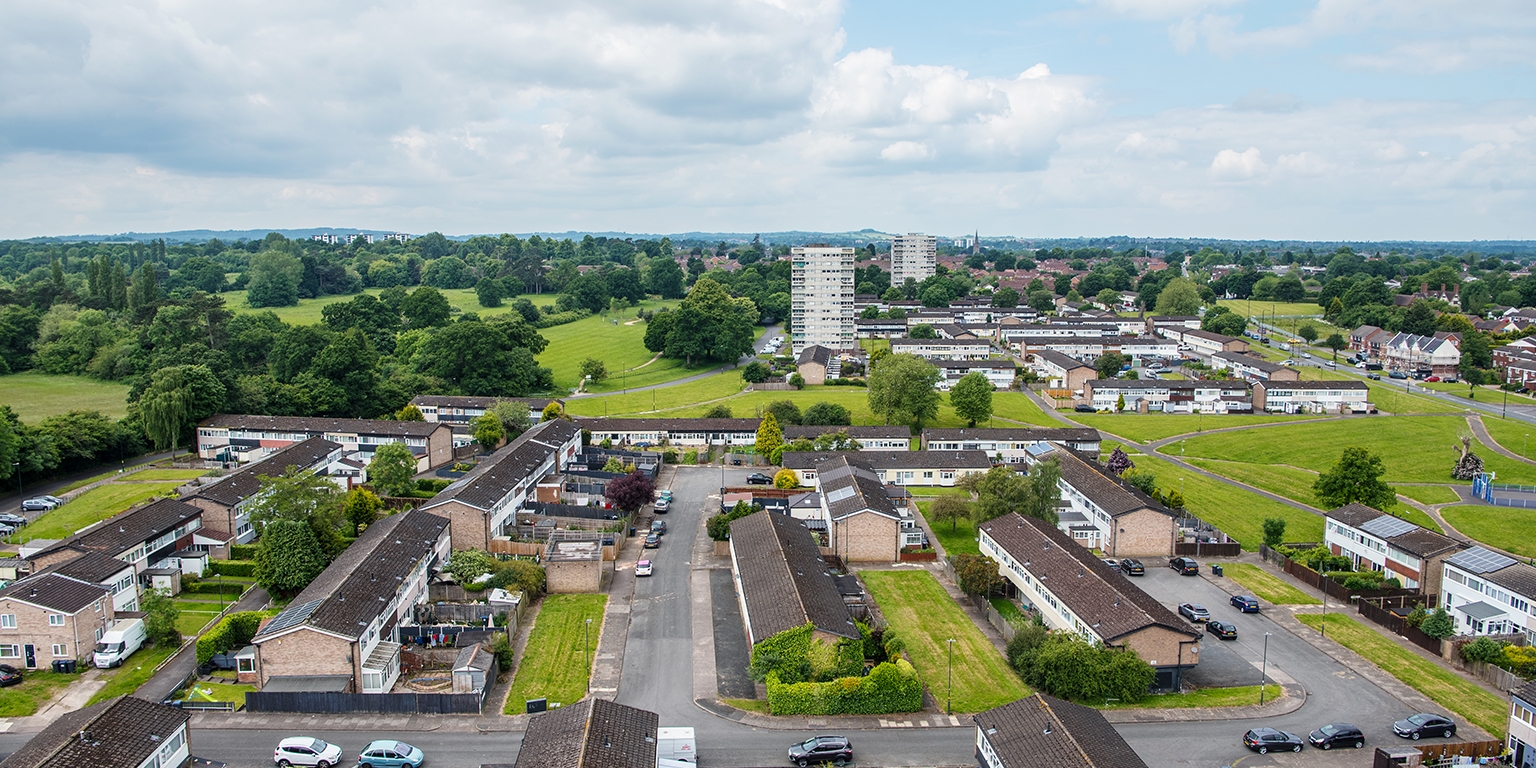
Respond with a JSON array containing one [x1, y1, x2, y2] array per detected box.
[[731, 511, 859, 641]]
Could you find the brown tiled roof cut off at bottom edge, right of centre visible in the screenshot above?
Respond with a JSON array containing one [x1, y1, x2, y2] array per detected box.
[[974, 693, 1146, 768]]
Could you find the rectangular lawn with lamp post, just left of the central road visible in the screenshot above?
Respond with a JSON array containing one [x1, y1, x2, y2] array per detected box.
[[507, 594, 608, 714]]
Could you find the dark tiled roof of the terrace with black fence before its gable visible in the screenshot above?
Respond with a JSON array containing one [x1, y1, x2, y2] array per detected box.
[[257, 510, 449, 639]]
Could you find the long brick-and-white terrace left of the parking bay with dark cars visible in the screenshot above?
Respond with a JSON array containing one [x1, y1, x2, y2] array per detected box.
[[978, 511, 1201, 690]]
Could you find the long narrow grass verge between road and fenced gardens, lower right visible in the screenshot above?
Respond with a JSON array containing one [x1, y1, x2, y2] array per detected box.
[[1296, 613, 1510, 739]]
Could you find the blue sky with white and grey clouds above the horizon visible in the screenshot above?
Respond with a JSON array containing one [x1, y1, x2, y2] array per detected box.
[[0, 0, 1536, 240]]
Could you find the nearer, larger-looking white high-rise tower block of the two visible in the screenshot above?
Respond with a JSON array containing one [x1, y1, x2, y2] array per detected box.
[[790, 246, 859, 355]]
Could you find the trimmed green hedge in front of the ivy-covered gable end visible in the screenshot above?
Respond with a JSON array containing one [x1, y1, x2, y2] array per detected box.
[[768, 659, 923, 714]]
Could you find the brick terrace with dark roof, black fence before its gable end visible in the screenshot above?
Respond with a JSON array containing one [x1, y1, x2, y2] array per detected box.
[[250, 510, 450, 693]]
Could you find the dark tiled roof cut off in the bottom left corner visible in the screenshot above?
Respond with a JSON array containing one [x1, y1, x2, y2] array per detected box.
[[0, 696, 192, 768]]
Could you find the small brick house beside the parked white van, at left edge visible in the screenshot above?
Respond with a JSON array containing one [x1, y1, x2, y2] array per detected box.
[[0, 573, 115, 670]]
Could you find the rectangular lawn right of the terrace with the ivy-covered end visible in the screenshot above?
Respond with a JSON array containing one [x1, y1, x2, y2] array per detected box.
[[859, 571, 1029, 713]]
